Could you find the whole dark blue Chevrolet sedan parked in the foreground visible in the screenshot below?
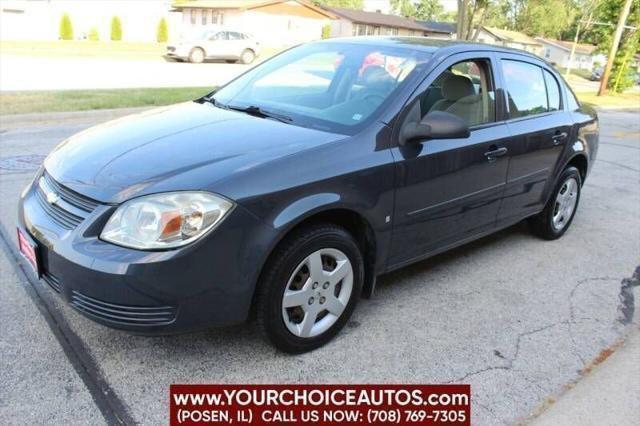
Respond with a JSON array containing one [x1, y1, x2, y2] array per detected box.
[[18, 37, 598, 353]]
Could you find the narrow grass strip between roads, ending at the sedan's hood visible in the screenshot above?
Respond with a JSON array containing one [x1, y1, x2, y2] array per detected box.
[[0, 87, 212, 115]]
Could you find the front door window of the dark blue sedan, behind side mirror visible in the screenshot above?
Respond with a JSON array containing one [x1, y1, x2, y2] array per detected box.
[[414, 59, 496, 126]]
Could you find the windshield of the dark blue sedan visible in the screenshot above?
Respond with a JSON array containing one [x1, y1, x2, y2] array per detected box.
[[214, 43, 430, 134]]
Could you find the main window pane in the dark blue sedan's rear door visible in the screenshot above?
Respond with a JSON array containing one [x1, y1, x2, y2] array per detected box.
[[502, 59, 547, 118]]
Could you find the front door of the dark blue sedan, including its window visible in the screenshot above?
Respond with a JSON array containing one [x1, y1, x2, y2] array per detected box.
[[389, 53, 510, 267]]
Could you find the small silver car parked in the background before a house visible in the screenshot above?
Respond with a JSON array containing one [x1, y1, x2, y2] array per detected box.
[[166, 29, 260, 64]]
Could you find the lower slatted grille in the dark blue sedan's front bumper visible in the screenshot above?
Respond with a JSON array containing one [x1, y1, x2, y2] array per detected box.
[[71, 290, 176, 327]]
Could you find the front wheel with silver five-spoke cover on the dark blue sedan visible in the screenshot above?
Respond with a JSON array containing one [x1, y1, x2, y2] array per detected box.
[[256, 224, 364, 354]]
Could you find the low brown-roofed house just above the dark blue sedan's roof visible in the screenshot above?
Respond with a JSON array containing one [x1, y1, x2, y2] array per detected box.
[[325, 7, 425, 37]]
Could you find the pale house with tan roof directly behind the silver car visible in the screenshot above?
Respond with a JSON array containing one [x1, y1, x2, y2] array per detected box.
[[173, 0, 335, 46]]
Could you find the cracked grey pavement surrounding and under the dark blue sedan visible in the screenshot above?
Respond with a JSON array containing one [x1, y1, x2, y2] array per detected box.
[[0, 111, 640, 425]]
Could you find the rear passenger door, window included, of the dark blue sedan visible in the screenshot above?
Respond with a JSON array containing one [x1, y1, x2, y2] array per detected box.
[[498, 54, 572, 226]]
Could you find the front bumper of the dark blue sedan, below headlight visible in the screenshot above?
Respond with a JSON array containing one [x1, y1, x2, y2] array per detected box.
[[18, 173, 268, 334]]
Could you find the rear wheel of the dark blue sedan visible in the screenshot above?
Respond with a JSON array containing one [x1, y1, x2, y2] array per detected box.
[[529, 166, 582, 240]]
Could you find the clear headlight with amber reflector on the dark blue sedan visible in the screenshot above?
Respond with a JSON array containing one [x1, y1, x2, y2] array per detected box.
[[100, 192, 233, 250]]
